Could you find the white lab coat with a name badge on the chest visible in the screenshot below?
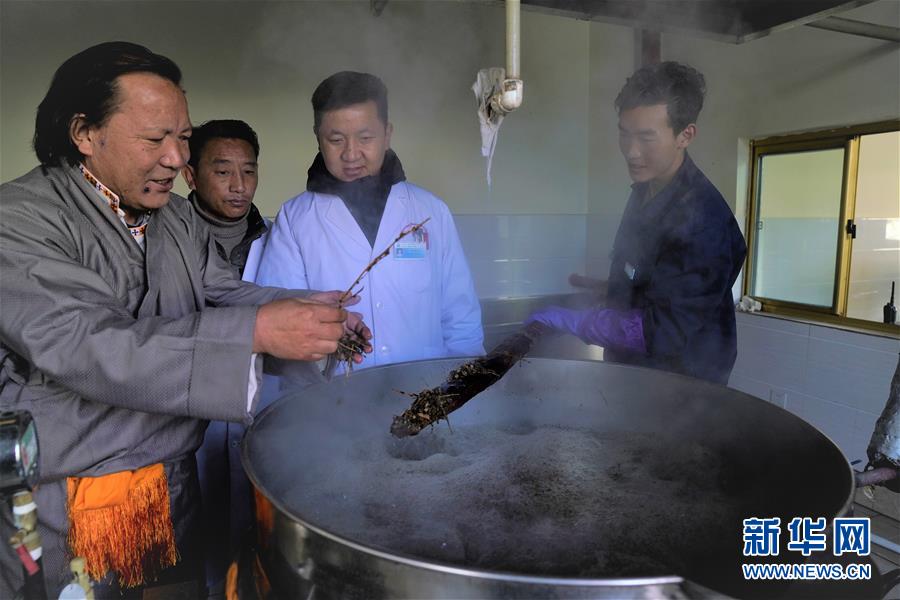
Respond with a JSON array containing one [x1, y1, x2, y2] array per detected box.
[[255, 181, 484, 368]]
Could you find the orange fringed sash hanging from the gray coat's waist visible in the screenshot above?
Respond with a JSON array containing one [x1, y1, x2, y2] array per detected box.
[[66, 463, 178, 588]]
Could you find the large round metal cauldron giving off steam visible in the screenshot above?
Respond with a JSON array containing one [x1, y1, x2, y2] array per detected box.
[[243, 359, 859, 598]]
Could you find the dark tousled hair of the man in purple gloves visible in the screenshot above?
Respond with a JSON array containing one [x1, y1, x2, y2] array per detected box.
[[615, 61, 706, 134]]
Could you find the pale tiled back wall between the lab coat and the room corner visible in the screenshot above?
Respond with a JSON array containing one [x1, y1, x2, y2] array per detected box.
[[454, 215, 587, 298]]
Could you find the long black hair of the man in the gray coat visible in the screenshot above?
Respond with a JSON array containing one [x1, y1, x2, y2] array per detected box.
[[32, 42, 181, 166]]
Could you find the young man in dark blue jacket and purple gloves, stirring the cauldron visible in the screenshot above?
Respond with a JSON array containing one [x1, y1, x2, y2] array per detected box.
[[528, 62, 747, 384]]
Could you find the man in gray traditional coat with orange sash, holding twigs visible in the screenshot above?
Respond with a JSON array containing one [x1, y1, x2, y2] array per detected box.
[[0, 42, 368, 598]]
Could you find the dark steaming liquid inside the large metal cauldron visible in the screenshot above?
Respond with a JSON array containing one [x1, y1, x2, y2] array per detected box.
[[289, 426, 753, 577]]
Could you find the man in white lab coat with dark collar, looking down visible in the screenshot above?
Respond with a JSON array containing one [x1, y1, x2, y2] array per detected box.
[[256, 71, 484, 367]]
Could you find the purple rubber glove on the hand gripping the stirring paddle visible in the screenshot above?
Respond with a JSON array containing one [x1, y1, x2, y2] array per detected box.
[[525, 306, 647, 354]]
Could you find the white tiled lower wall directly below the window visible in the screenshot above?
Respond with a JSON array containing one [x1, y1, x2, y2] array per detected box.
[[729, 313, 900, 465]]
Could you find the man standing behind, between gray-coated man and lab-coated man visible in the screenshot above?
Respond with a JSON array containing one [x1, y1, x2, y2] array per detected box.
[[183, 120, 268, 278]]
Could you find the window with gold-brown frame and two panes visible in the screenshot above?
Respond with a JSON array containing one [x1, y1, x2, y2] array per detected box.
[[744, 120, 900, 334]]
